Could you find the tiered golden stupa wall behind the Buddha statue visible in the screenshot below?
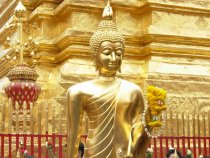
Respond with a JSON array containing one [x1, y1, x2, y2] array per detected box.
[[0, 0, 210, 136]]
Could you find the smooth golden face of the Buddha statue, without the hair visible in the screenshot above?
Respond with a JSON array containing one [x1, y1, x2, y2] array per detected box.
[[96, 41, 124, 74]]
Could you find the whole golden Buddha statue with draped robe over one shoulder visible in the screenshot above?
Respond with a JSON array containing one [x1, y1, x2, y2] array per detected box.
[[67, 2, 149, 158]]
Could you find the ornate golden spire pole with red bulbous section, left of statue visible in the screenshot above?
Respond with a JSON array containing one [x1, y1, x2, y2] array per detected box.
[[5, 2, 41, 133]]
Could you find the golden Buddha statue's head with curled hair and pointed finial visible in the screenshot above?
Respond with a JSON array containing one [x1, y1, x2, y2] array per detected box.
[[90, 2, 124, 75]]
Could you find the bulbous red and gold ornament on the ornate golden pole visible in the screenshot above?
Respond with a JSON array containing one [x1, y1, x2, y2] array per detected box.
[[5, 64, 41, 110]]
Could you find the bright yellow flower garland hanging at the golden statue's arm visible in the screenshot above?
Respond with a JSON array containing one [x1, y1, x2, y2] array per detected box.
[[147, 86, 167, 127]]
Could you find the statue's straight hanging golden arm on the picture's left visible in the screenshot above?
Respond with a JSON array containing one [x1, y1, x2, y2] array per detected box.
[[67, 88, 83, 158]]
